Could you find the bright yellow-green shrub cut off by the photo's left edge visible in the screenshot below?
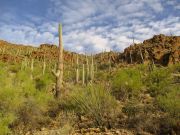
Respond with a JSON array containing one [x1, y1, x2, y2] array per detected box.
[[0, 69, 23, 135]]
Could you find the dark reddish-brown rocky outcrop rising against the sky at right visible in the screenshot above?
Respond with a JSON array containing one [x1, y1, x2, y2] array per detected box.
[[119, 34, 180, 66]]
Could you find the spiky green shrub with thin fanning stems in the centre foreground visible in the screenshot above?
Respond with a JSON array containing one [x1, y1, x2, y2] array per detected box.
[[65, 85, 117, 126]]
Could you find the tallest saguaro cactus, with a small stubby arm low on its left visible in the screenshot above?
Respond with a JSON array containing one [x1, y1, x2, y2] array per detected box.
[[52, 24, 63, 98]]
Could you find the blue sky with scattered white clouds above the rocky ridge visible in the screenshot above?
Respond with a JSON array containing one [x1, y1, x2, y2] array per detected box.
[[0, 0, 180, 53]]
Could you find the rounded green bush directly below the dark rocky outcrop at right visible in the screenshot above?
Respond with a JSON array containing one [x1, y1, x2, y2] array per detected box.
[[145, 68, 172, 97]]
